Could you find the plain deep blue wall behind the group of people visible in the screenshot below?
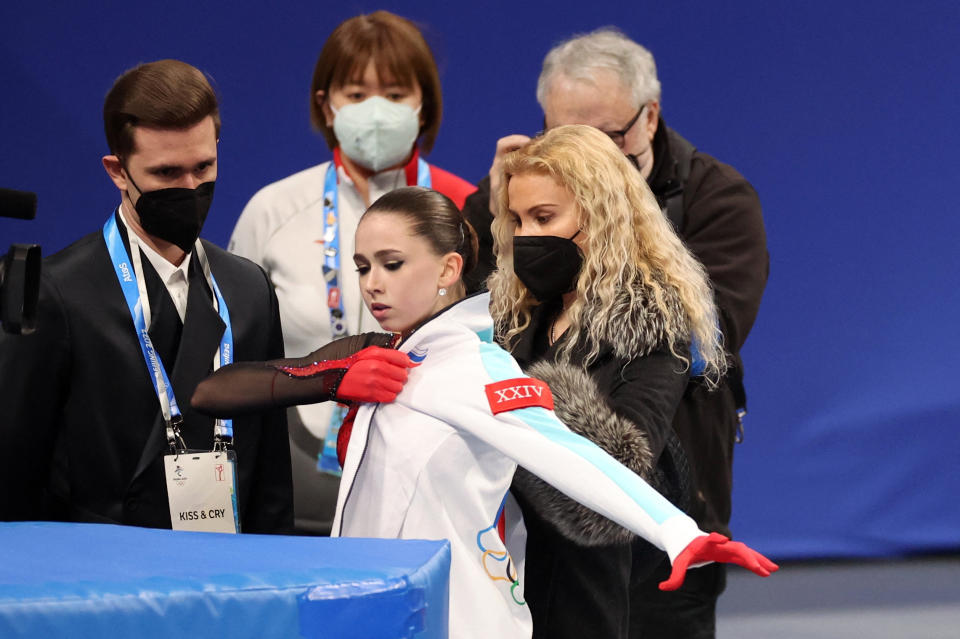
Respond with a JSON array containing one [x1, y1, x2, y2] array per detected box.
[[0, 0, 960, 558]]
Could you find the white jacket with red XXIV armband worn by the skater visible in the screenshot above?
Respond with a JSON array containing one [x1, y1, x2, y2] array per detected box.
[[333, 294, 705, 638]]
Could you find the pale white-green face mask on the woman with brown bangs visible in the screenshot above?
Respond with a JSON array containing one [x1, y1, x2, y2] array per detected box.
[[330, 95, 420, 173]]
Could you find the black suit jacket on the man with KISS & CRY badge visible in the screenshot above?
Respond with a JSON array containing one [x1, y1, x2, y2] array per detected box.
[[0, 212, 293, 532]]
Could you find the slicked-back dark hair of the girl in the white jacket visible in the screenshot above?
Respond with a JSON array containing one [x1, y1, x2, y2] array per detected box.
[[364, 186, 478, 296]]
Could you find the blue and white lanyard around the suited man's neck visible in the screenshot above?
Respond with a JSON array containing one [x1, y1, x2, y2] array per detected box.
[[103, 215, 233, 447]]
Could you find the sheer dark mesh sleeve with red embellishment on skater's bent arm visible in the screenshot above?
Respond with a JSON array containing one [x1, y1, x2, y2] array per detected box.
[[190, 333, 393, 418]]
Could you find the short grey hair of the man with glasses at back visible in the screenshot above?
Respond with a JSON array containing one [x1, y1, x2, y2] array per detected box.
[[537, 27, 660, 108]]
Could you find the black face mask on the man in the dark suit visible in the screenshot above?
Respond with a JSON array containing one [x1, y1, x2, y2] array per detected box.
[[127, 171, 216, 253]]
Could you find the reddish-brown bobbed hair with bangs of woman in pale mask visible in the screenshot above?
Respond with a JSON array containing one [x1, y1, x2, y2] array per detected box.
[[310, 11, 443, 155]]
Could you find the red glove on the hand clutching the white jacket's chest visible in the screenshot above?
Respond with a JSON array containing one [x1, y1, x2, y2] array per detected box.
[[337, 346, 417, 402]]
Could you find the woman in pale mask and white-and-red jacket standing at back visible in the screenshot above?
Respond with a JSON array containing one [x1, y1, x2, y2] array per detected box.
[[229, 11, 475, 534]]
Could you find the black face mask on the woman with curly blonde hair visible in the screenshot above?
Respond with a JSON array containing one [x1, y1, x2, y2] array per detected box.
[[513, 231, 583, 302]]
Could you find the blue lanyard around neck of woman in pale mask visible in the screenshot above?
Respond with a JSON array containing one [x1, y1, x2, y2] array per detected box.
[[323, 156, 432, 339]]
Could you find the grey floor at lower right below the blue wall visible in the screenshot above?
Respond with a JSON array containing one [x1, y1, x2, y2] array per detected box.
[[717, 555, 960, 639]]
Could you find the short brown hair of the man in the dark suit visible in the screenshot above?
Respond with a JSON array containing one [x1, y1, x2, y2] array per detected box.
[[103, 60, 220, 156]]
